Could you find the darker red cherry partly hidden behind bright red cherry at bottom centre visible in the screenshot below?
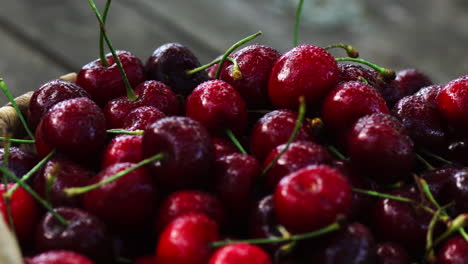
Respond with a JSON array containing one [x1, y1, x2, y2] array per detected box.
[[155, 191, 226, 231]]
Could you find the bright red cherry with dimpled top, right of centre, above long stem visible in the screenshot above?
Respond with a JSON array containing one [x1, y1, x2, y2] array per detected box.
[[274, 165, 351, 233]]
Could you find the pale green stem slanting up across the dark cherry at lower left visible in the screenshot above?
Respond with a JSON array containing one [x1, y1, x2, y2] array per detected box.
[[63, 153, 165, 197]]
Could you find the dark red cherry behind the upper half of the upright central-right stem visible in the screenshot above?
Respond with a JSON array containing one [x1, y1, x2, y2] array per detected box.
[[250, 110, 314, 161]]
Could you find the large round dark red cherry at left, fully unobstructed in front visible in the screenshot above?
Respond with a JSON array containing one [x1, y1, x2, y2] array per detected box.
[[36, 97, 106, 160]]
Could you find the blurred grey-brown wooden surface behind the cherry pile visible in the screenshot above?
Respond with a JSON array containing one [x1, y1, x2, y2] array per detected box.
[[0, 0, 468, 103]]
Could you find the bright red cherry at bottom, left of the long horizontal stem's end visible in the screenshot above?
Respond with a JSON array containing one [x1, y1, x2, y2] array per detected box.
[[156, 214, 219, 264]]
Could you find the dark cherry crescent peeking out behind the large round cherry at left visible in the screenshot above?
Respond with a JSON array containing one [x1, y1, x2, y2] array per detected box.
[[28, 80, 90, 129]]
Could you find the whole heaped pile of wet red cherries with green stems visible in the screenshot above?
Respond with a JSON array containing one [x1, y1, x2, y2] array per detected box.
[[0, 39, 468, 264]]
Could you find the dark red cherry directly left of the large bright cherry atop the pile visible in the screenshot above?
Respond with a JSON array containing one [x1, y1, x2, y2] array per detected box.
[[220, 44, 281, 108]]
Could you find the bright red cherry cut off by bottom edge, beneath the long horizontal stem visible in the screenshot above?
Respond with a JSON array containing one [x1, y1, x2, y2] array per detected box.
[[208, 243, 272, 264]]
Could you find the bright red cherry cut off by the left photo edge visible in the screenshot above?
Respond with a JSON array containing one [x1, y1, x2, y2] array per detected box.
[[0, 183, 39, 243]]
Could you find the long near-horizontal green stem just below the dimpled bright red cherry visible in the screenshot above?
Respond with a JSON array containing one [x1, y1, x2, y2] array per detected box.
[[210, 221, 341, 247]]
